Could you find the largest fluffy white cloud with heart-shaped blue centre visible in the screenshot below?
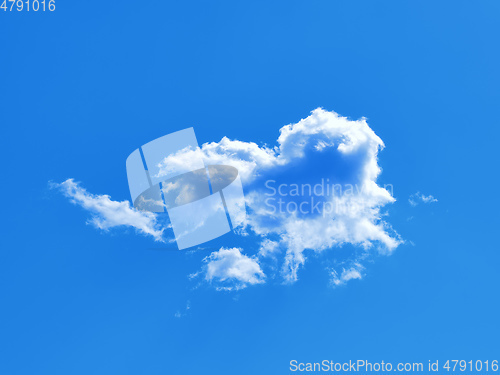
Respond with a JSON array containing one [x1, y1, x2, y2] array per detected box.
[[188, 108, 401, 282]]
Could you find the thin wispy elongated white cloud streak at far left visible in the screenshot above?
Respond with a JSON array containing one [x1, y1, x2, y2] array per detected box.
[[50, 179, 164, 242]]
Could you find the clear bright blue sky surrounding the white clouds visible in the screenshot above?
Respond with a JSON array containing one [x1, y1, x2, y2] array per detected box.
[[0, 1, 500, 374]]
